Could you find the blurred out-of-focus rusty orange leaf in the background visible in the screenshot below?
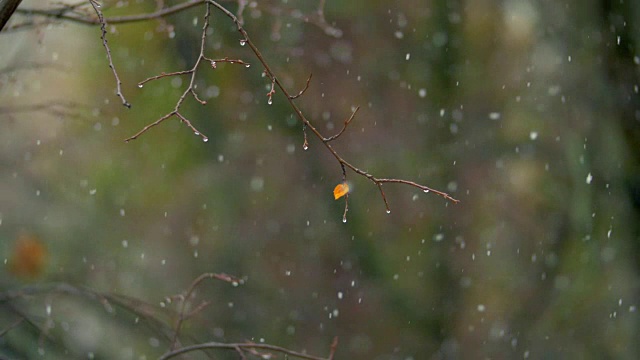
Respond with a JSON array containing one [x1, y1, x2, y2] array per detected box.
[[9, 234, 47, 279]]
